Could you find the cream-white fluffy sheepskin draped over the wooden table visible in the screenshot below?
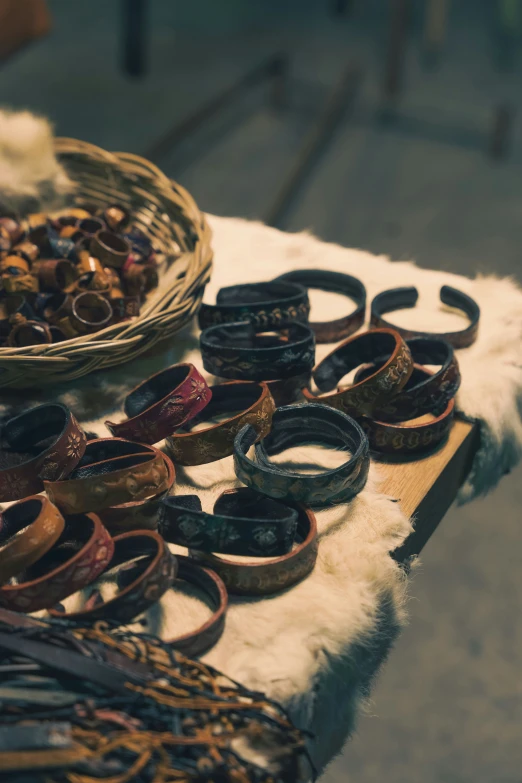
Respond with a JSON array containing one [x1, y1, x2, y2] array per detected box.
[[0, 113, 522, 771]]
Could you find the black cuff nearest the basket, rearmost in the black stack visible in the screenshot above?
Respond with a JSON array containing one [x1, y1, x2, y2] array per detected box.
[[199, 280, 310, 329]]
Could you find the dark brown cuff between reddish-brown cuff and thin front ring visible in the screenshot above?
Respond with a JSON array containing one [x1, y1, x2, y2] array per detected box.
[[49, 530, 177, 623]]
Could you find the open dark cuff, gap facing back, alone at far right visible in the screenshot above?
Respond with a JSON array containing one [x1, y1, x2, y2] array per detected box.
[[370, 285, 480, 348]]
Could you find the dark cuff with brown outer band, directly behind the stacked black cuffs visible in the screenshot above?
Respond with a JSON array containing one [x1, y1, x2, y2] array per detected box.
[[276, 269, 366, 343]]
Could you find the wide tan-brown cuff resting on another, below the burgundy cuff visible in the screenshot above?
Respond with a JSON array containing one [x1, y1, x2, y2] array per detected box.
[[45, 438, 168, 514]]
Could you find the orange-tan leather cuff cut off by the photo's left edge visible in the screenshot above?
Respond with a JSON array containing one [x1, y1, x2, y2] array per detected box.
[[0, 495, 65, 584]]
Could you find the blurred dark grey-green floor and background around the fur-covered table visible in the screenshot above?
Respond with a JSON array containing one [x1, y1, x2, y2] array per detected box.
[[0, 0, 522, 783]]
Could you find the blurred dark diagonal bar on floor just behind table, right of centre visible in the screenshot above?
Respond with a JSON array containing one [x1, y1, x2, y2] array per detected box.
[[265, 62, 362, 226]]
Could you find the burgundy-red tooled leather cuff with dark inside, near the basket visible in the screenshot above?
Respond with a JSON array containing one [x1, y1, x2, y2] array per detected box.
[[105, 364, 212, 443]]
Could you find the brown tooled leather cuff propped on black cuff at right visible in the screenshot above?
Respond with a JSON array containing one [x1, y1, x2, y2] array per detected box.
[[303, 329, 413, 414]]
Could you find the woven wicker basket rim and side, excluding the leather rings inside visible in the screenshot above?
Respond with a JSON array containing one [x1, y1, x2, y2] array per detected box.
[[0, 138, 212, 388]]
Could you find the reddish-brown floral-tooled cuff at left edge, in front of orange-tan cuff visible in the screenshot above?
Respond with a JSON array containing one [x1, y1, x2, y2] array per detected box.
[[0, 514, 114, 613]]
